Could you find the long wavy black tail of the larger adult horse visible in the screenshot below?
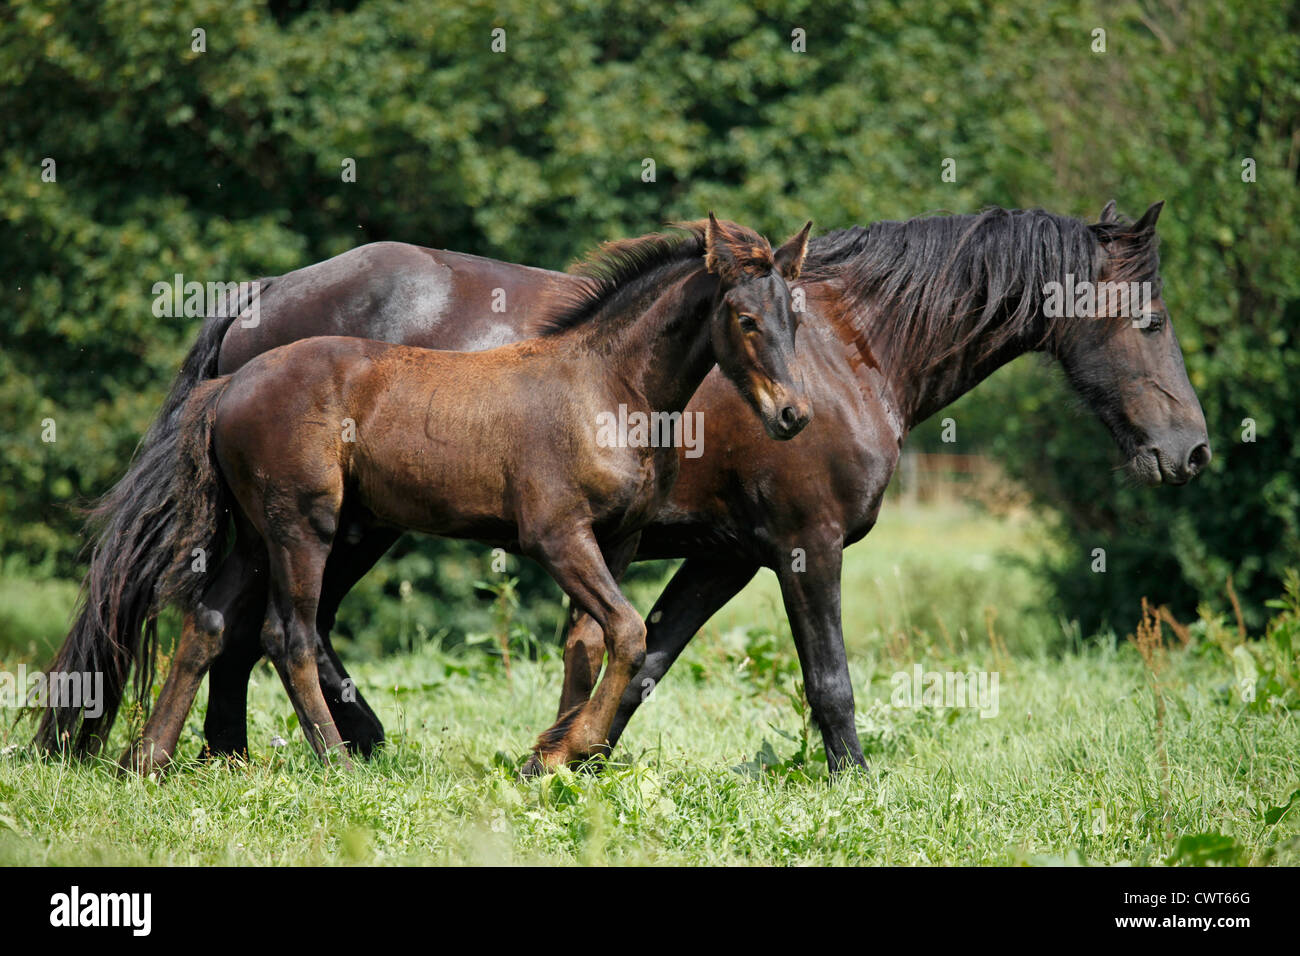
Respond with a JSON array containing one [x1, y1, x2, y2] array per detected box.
[[35, 280, 272, 754]]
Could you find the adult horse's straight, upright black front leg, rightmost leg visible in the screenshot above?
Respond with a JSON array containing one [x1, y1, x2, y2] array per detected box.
[[776, 537, 867, 773]]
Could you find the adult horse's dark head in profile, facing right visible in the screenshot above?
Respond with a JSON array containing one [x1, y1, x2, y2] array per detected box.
[[1056, 200, 1210, 485]]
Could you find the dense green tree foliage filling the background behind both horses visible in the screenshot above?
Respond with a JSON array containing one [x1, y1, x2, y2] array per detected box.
[[0, 0, 1300, 642]]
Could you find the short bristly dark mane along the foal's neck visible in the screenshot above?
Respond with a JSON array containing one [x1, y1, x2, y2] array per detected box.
[[536, 220, 771, 336]]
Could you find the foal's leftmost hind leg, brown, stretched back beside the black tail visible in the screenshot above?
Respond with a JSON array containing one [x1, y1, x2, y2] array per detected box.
[[121, 551, 248, 774]]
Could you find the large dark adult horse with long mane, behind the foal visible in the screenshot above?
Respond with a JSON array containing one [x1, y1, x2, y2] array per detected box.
[[38, 203, 1210, 770]]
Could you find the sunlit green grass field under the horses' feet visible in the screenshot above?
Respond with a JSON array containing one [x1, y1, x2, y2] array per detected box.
[[0, 506, 1300, 865]]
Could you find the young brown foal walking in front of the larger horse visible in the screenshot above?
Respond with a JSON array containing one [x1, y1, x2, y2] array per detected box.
[[124, 215, 811, 773]]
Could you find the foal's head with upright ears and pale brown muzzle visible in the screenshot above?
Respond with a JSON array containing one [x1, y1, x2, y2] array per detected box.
[[705, 213, 813, 440]]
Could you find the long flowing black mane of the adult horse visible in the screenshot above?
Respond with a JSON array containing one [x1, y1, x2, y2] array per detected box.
[[803, 207, 1160, 365]]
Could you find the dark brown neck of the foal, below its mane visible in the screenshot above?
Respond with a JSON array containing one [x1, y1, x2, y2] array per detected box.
[[601, 264, 718, 412]]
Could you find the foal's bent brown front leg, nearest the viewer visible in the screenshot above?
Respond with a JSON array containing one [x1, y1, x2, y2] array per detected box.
[[525, 527, 646, 773]]
